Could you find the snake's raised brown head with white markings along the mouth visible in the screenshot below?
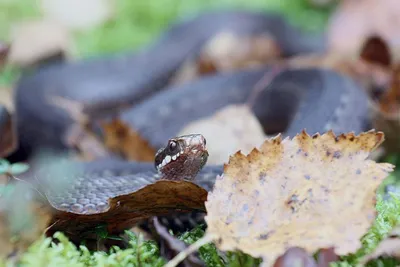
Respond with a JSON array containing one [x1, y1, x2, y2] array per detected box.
[[154, 134, 208, 180]]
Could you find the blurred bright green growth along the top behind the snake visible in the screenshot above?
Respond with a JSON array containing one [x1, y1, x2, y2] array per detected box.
[[0, 0, 331, 57]]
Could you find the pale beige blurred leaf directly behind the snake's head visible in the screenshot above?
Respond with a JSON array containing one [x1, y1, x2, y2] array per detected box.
[[178, 105, 265, 164]]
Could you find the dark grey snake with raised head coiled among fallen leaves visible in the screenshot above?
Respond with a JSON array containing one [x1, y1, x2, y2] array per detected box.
[[5, 11, 368, 241]]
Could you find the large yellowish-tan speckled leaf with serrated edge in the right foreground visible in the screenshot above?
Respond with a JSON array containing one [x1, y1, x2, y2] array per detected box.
[[205, 130, 394, 266]]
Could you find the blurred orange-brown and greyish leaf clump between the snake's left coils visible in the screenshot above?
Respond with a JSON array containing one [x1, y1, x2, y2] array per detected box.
[[49, 96, 156, 162]]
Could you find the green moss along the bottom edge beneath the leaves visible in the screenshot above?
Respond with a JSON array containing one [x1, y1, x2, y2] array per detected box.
[[0, 189, 400, 267]]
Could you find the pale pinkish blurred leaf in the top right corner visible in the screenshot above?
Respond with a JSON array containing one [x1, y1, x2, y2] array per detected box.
[[327, 0, 400, 61]]
